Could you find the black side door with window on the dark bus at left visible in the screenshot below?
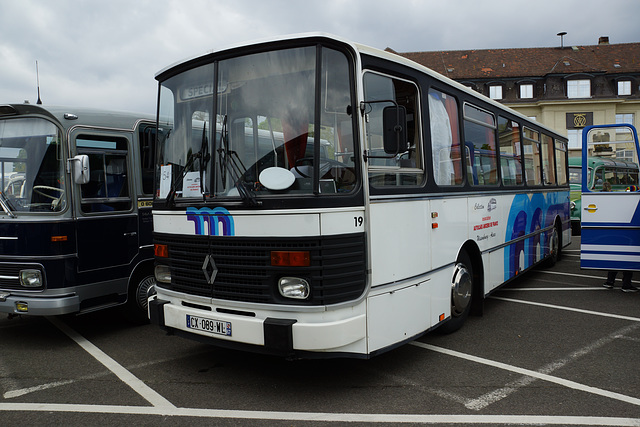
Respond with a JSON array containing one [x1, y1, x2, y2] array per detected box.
[[72, 129, 139, 278]]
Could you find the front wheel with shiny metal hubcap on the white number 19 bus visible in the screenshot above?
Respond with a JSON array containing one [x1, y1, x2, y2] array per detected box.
[[438, 252, 474, 334]]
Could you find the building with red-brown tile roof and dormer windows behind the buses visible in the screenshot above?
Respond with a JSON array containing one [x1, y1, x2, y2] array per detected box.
[[387, 37, 640, 156]]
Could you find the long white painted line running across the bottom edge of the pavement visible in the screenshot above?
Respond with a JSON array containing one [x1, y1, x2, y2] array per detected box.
[[0, 402, 640, 426]]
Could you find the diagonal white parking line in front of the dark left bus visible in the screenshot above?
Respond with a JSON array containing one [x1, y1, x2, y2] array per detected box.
[[47, 317, 175, 408]]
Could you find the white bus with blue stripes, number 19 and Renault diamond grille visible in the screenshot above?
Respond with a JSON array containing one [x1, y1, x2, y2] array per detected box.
[[149, 34, 571, 358]]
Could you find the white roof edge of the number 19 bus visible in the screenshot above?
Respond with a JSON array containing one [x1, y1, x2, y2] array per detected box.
[[155, 32, 567, 141]]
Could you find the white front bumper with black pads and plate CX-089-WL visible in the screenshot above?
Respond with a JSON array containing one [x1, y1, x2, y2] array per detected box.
[[149, 297, 367, 355]]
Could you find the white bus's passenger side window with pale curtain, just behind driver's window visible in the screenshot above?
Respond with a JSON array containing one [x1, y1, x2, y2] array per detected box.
[[429, 89, 463, 185]]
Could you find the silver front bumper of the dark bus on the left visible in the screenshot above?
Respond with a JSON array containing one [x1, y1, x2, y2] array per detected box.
[[0, 291, 80, 316]]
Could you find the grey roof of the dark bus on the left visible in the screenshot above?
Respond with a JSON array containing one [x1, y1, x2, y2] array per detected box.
[[0, 104, 155, 130]]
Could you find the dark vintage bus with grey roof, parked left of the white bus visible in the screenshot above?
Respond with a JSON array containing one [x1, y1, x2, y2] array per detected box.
[[0, 104, 156, 320]]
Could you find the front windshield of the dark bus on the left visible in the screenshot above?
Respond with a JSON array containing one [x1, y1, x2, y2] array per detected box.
[[0, 118, 66, 216]]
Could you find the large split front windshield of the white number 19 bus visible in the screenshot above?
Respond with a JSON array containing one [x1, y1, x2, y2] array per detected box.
[[156, 45, 358, 205]]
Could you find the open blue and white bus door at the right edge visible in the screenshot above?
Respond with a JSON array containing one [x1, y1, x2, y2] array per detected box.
[[580, 124, 640, 270]]
